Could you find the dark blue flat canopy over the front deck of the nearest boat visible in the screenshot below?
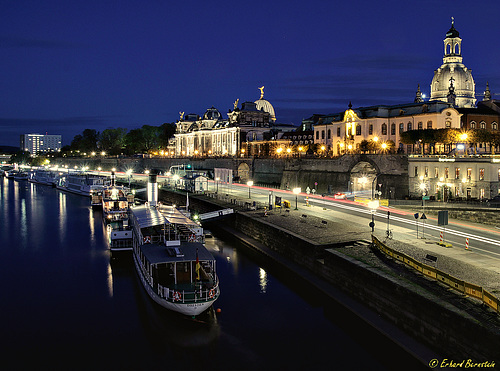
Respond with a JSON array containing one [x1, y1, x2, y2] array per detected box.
[[140, 242, 214, 264]]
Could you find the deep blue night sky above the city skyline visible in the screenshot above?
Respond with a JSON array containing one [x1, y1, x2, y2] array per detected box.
[[0, 0, 500, 146]]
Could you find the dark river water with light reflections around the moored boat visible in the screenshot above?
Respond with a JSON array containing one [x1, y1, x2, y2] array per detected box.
[[0, 178, 418, 370]]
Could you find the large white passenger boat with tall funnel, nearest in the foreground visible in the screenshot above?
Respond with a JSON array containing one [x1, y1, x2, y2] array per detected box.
[[130, 174, 219, 316]]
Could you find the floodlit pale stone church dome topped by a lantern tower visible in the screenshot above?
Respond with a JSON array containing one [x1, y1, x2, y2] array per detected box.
[[430, 21, 476, 108]]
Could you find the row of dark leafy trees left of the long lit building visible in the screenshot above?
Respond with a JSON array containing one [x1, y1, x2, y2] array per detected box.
[[66, 123, 176, 155]]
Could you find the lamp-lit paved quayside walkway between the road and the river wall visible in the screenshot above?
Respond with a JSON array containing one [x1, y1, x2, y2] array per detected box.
[[202, 196, 500, 297]]
